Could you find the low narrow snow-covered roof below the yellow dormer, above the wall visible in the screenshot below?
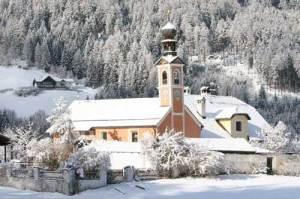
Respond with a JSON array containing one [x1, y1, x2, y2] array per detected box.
[[187, 138, 256, 153]]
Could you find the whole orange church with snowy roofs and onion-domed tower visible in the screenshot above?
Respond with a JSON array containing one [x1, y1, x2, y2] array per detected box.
[[50, 23, 268, 142]]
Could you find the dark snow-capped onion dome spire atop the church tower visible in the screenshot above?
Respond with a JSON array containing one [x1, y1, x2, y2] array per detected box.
[[161, 21, 177, 56]]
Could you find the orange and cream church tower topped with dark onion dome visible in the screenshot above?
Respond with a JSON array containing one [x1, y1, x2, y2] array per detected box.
[[156, 23, 185, 133]]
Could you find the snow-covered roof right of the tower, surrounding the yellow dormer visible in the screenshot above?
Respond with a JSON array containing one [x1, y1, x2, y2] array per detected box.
[[184, 95, 269, 138]]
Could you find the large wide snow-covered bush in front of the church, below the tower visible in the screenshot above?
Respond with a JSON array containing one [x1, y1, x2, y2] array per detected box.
[[142, 130, 224, 177]]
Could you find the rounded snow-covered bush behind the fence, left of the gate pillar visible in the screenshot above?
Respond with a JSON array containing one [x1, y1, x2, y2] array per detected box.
[[66, 145, 110, 176]]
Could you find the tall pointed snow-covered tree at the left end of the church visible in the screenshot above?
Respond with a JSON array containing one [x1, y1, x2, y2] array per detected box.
[[47, 97, 79, 144]]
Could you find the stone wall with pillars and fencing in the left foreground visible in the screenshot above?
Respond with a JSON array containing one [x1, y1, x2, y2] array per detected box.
[[0, 166, 107, 195]]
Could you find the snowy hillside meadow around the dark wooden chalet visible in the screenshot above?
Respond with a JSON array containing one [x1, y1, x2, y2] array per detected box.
[[0, 66, 96, 116]]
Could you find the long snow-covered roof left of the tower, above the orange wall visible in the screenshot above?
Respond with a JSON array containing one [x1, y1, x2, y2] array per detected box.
[[70, 98, 170, 131]]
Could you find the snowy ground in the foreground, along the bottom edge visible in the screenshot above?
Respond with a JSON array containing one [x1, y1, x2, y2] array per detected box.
[[0, 175, 300, 199]]
